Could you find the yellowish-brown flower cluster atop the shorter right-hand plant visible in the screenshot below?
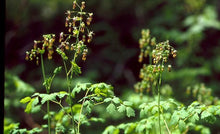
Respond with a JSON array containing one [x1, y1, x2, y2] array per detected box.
[[134, 29, 177, 93]]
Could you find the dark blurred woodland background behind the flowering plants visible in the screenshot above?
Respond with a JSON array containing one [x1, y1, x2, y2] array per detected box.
[[4, 0, 220, 132]]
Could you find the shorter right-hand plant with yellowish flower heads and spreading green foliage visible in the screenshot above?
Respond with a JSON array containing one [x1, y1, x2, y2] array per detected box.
[[103, 29, 220, 134]]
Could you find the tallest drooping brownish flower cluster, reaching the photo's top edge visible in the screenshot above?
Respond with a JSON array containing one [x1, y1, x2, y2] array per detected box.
[[57, 0, 94, 61]]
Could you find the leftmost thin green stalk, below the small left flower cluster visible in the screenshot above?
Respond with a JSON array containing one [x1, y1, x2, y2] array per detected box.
[[41, 54, 51, 134]]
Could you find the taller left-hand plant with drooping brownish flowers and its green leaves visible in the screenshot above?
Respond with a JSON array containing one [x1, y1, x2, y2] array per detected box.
[[12, 0, 135, 134]]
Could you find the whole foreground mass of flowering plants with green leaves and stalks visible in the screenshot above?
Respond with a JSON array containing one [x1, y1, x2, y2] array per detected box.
[[4, 0, 220, 134]]
